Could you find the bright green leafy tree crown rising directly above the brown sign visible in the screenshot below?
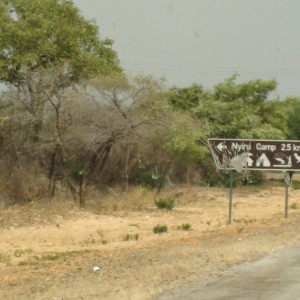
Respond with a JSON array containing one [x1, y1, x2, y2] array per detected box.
[[194, 75, 287, 139]]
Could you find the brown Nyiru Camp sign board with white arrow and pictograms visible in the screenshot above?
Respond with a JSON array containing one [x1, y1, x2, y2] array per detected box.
[[208, 139, 300, 172]]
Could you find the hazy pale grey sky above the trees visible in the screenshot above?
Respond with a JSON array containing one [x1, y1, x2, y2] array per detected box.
[[73, 0, 300, 97]]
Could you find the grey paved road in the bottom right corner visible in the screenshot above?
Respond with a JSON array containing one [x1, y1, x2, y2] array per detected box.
[[157, 244, 300, 300]]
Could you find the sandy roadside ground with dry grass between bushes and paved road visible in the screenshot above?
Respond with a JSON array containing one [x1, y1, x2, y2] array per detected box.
[[0, 179, 300, 300]]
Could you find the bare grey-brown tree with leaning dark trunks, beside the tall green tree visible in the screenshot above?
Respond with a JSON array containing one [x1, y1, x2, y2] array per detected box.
[[87, 75, 166, 185]]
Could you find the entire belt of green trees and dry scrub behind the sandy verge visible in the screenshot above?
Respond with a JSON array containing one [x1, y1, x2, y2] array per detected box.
[[0, 0, 300, 206]]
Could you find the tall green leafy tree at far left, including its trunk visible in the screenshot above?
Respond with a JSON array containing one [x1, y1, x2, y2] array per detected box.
[[0, 0, 122, 202]]
